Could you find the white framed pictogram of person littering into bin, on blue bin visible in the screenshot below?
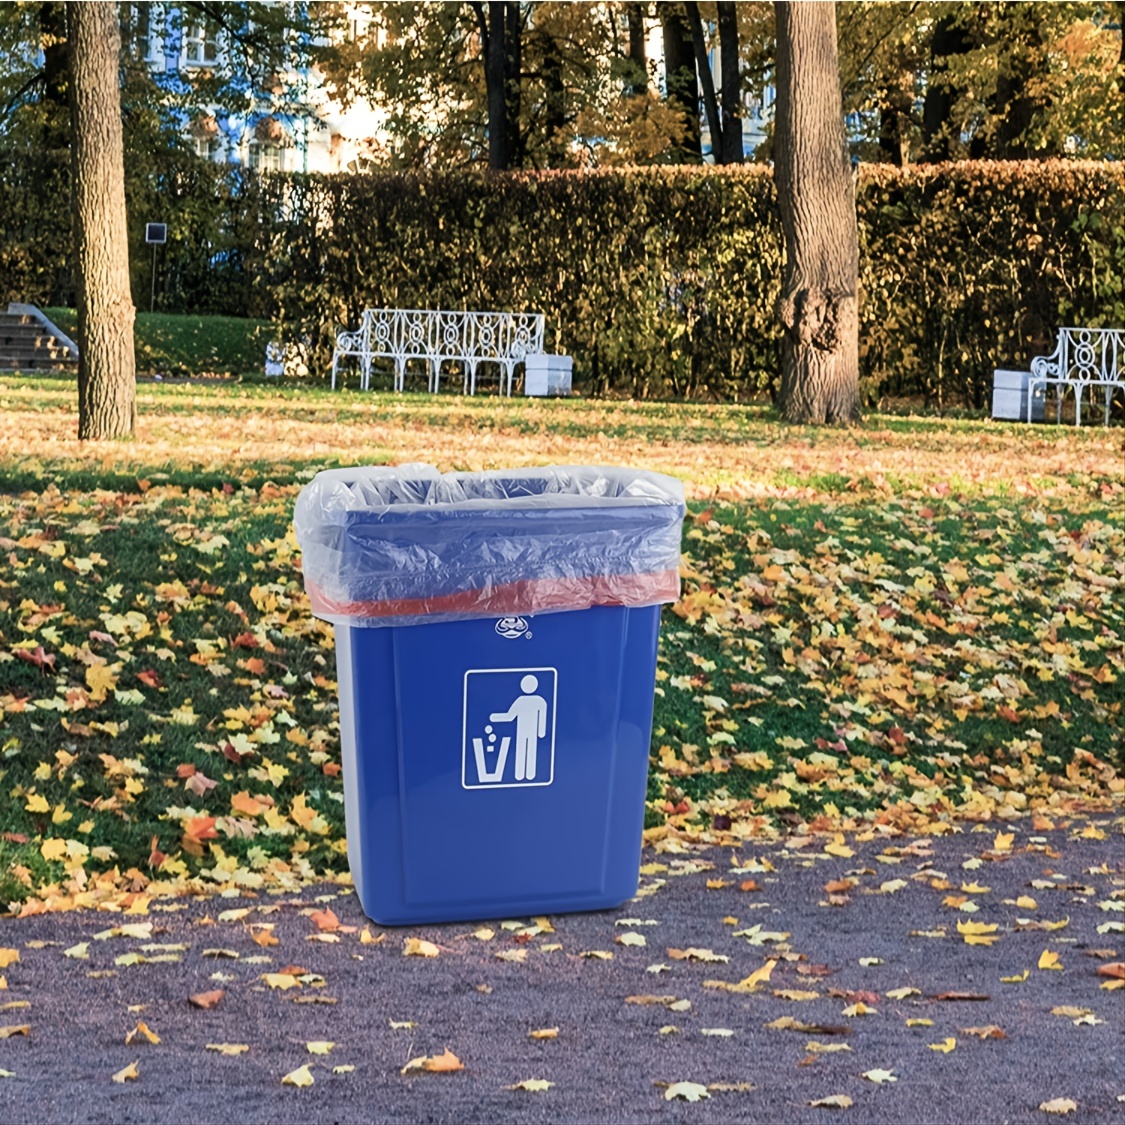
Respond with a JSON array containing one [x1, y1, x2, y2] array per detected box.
[[461, 668, 558, 789]]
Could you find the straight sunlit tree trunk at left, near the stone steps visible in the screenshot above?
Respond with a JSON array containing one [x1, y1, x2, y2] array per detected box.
[[66, 0, 136, 439]]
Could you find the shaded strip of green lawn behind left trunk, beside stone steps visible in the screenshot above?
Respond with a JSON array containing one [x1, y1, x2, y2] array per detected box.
[[44, 308, 276, 376]]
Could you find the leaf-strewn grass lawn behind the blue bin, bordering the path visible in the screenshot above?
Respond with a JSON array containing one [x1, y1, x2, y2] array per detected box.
[[0, 378, 1125, 911]]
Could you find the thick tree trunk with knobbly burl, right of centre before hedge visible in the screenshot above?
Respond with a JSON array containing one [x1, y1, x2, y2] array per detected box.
[[774, 0, 860, 423]]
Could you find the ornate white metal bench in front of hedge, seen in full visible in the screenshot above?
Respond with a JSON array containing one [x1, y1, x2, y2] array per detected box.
[[332, 308, 546, 395]]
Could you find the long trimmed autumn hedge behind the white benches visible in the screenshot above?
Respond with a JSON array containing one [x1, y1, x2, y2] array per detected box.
[[0, 161, 1125, 407]]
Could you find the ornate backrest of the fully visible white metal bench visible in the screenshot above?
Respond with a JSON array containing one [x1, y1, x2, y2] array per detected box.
[[360, 308, 546, 360]]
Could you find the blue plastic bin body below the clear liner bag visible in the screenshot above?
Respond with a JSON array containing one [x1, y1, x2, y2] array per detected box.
[[336, 606, 660, 926]]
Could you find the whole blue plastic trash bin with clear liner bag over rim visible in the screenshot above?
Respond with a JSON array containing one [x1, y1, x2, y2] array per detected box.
[[295, 465, 684, 925]]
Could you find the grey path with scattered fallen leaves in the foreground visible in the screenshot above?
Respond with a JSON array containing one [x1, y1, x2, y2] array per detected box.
[[0, 817, 1125, 1125]]
